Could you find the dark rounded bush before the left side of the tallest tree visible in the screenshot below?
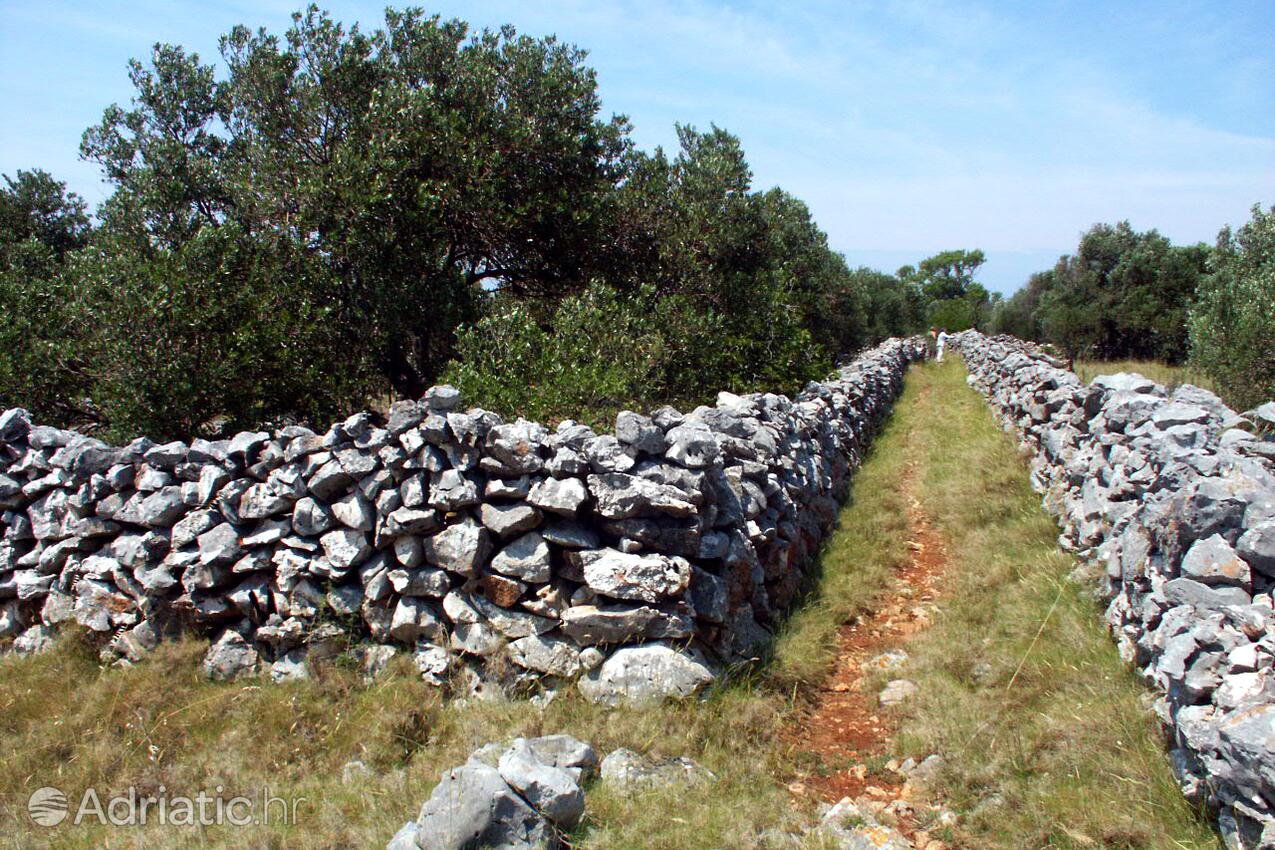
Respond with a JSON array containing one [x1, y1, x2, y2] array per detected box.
[[74, 224, 368, 440]]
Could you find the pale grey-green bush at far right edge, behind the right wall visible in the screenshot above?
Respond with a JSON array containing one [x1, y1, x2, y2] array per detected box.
[[1190, 205, 1275, 408]]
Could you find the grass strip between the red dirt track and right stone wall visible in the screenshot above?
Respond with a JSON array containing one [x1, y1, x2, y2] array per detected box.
[[898, 363, 1219, 850]]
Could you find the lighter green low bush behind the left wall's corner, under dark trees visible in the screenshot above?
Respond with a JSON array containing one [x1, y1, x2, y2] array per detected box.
[[446, 284, 826, 424]]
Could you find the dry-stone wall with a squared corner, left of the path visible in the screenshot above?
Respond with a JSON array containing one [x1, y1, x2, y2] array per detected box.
[[0, 339, 924, 701]]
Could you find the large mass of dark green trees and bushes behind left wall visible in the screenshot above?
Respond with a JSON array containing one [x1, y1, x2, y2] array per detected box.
[[0, 6, 986, 438]]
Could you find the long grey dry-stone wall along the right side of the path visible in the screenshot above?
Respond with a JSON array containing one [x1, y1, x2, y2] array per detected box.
[[955, 331, 1275, 847]]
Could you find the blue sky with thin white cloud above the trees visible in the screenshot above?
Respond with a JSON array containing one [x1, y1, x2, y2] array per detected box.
[[0, 0, 1275, 292]]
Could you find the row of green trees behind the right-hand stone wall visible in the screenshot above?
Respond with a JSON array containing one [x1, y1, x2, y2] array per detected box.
[[989, 206, 1275, 407]]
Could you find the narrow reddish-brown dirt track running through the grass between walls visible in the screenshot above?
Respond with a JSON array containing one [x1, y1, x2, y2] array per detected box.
[[789, 387, 949, 837]]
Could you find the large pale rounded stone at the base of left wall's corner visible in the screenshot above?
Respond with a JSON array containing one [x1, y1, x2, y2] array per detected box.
[[578, 644, 715, 706]]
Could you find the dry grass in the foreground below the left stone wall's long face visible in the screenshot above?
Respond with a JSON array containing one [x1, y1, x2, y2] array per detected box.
[[0, 638, 801, 850]]
